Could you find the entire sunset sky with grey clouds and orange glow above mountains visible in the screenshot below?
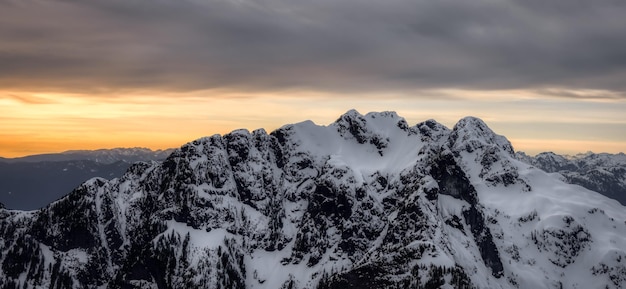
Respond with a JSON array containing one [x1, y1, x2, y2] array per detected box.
[[0, 0, 626, 157]]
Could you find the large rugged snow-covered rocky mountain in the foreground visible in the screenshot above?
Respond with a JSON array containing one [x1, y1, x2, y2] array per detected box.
[[0, 111, 626, 289]]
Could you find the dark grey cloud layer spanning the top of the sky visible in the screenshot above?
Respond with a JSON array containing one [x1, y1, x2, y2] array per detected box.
[[0, 0, 626, 98]]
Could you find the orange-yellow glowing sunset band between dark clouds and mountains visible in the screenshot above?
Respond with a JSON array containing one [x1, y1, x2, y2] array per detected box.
[[0, 88, 626, 157]]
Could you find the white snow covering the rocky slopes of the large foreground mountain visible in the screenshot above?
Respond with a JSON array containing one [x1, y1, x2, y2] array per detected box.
[[2, 111, 626, 289]]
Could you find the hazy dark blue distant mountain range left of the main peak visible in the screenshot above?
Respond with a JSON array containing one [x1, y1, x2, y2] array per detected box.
[[0, 148, 173, 210]]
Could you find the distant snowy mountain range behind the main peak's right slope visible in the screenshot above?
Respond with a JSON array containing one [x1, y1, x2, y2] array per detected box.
[[516, 152, 626, 205]]
